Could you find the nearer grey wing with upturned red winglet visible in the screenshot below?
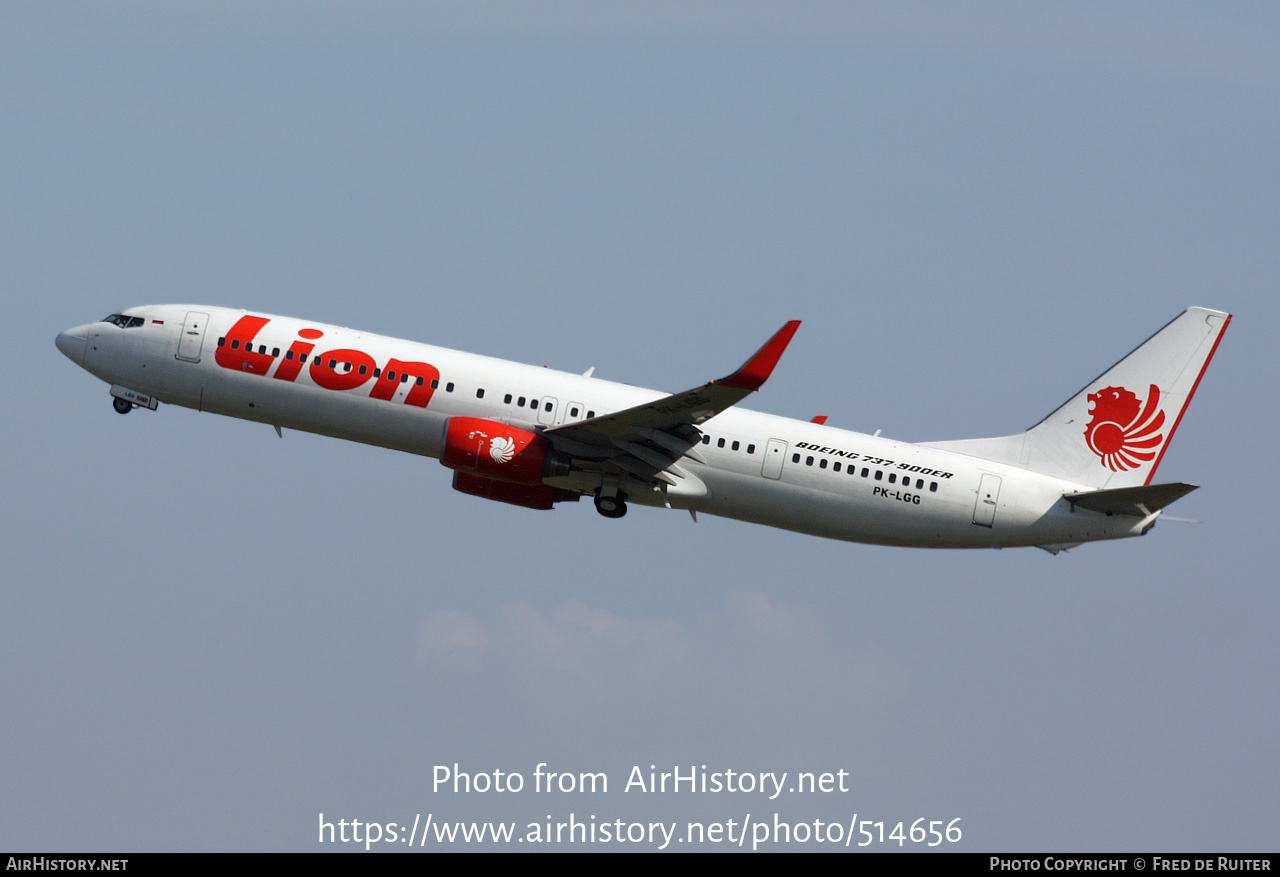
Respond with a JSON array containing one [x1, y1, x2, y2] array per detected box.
[[543, 320, 800, 485]]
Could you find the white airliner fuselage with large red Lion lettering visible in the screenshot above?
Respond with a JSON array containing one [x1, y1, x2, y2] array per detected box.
[[58, 305, 1158, 548]]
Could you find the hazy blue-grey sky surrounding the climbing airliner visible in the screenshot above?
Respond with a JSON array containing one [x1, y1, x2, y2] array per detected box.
[[0, 3, 1280, 850]]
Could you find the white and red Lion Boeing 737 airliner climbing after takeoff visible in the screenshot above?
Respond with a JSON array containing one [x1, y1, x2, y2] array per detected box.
[[56, 305, 1231, 554]]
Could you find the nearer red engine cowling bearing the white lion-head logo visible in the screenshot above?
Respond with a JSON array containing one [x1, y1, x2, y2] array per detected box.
[[440, 417, 568, 481]]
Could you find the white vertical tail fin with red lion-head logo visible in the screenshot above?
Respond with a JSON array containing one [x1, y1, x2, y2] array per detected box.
[[929, 307, 1231, 488]]
